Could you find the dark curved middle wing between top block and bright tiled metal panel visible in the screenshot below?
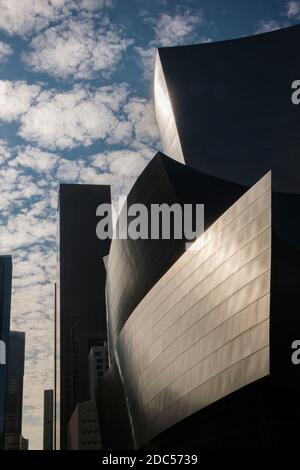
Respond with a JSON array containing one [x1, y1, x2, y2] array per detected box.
[[106, 153, 246, 352]]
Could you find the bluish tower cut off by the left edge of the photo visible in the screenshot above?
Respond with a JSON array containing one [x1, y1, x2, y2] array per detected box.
[[0, 256, 12, 449]]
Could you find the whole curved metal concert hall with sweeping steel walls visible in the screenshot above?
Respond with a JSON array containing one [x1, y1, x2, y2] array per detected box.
[[97, 26, 300, 450]]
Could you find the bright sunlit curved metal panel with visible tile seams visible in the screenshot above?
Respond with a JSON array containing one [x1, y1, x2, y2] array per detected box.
[[115, 173, 271, 447]]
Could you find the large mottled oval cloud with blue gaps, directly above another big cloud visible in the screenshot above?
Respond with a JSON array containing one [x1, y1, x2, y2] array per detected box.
[[24, 18, 132, 79]]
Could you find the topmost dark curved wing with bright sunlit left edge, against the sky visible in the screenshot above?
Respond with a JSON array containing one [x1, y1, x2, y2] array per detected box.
[[154, 26, 300, 194]]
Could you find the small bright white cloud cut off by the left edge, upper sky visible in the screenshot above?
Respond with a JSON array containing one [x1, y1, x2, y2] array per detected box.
[[0, 80, 40, 122]]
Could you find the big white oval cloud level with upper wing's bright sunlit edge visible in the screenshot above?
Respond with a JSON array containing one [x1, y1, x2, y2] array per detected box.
[[19, 85, 127, 149]]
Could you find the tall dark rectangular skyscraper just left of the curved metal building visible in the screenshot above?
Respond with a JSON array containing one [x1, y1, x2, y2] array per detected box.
[[55, 184, 111, 449]]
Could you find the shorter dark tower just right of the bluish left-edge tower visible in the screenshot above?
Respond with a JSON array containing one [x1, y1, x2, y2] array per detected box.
[[5, 331, 25, 450]]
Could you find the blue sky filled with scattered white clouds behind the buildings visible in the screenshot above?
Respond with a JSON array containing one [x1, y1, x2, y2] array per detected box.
[[0, 0, 300, 449]]
